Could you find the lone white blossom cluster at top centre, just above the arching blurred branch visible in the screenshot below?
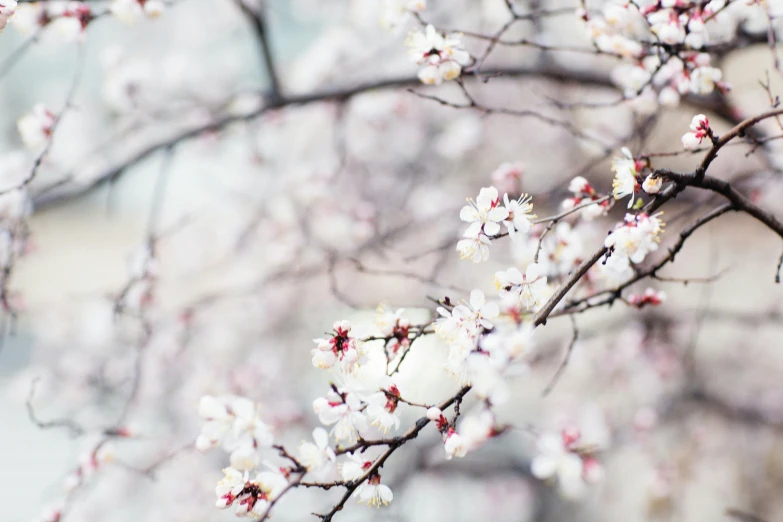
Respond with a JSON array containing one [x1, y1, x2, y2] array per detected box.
[[405, 25, 470, 85]]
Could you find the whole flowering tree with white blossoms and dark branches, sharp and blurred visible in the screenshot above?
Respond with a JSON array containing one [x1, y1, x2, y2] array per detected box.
[[0, 0, 783, 522]]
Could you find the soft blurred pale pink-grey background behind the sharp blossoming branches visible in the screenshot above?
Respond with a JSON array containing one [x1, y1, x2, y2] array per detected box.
[[0, 0, 783, 522]]
